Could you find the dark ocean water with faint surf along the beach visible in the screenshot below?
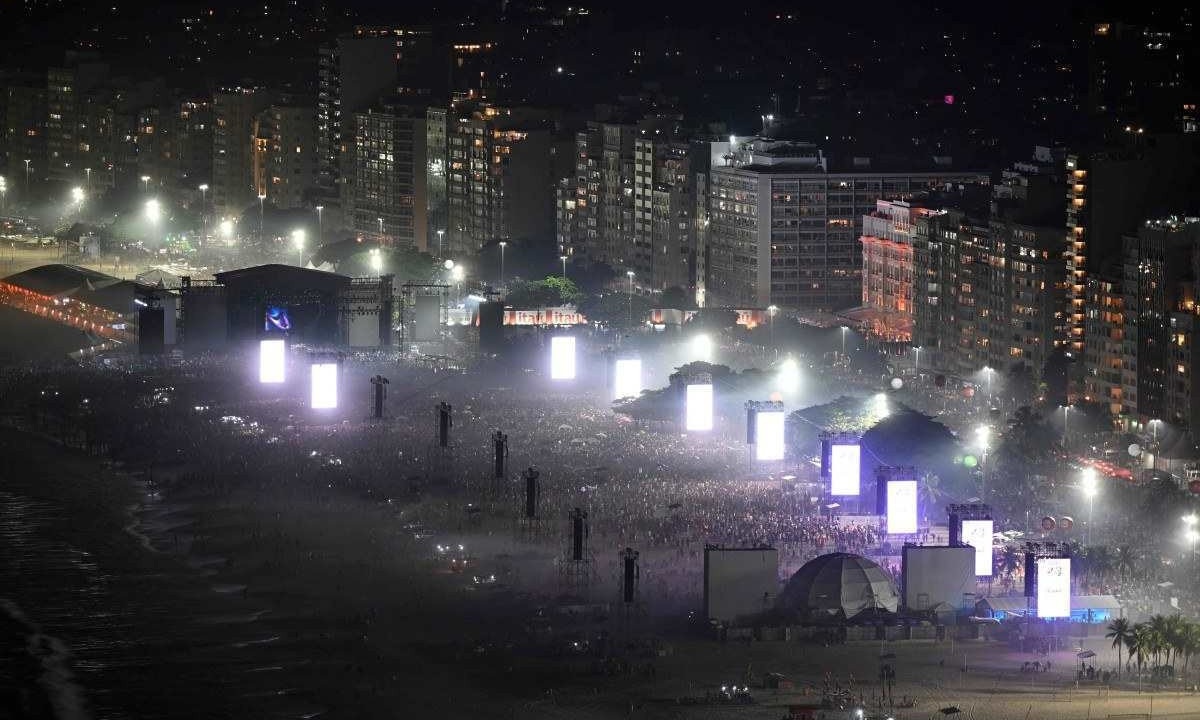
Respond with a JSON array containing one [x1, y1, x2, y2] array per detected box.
[[0, 485, 320, 720]]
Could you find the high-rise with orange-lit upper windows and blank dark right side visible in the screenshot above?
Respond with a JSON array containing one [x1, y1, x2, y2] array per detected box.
[[445, 103, 559, 257]]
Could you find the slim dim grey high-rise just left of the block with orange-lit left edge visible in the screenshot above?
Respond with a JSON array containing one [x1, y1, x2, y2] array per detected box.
[[212, 88, 271, 215]]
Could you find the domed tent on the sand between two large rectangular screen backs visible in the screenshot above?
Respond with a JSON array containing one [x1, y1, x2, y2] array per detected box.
[[779, 552, 900, 620]]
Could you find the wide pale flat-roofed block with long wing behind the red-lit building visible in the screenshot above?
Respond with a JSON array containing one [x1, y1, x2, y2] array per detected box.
[[706, 139, 988, 311]]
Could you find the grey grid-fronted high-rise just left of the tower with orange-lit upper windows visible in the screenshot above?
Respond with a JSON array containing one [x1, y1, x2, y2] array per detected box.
[[353, 103, 428, 251]]
